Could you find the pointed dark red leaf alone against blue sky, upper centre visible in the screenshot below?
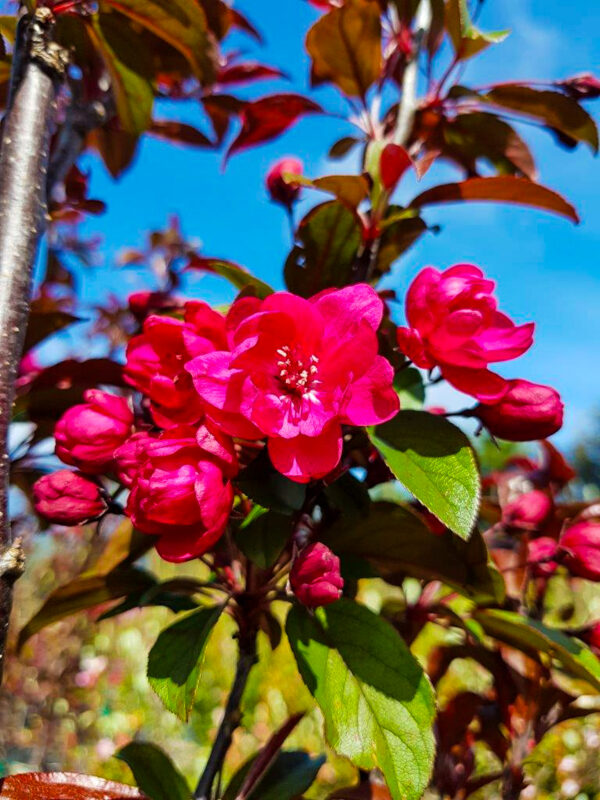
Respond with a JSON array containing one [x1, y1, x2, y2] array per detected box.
[[226, 94, 323, 159]]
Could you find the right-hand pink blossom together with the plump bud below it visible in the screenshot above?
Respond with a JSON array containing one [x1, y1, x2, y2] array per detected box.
[[398, 264, 563, 441]]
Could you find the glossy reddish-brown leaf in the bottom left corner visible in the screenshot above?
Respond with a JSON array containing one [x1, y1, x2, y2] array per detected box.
[[0, 772, 148, 800]]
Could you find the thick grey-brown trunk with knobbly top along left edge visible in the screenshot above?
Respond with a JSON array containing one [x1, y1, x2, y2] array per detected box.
[[0, 8, 66, 678]]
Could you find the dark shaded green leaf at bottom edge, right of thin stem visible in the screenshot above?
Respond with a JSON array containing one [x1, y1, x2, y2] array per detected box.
[[223, 750, 325, 800]]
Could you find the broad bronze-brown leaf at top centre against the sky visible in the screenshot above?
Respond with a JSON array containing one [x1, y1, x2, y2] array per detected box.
[[306, 0, 381, 97]]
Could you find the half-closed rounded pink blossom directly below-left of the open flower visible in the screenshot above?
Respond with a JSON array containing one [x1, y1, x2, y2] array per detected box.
[[126, 426, 237, 562]]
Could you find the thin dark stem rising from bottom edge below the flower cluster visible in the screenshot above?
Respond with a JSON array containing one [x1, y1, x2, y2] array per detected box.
[[194, 629, 257, 800]]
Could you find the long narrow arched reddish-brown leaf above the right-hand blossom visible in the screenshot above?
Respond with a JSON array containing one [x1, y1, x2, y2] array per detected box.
[[410, 176, 579, 223]]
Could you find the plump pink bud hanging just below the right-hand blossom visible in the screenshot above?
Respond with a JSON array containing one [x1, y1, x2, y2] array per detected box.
[[473, 379, 564, 442]]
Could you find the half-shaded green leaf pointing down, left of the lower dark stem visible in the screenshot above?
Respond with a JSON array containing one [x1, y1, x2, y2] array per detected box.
[[148, 606, 223, 722]]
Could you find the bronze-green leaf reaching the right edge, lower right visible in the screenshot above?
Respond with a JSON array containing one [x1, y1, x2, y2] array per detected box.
[[473, 609, 600, 692]]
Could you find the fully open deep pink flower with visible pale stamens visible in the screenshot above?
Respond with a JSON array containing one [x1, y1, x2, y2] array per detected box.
[[187, 284, 399, 483]]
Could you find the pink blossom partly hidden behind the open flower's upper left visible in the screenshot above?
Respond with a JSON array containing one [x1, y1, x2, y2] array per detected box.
[[124, 302, 226, 428]]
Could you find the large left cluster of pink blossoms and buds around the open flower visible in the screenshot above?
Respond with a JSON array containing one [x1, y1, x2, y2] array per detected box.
[[35, 285, 399, 584]]
